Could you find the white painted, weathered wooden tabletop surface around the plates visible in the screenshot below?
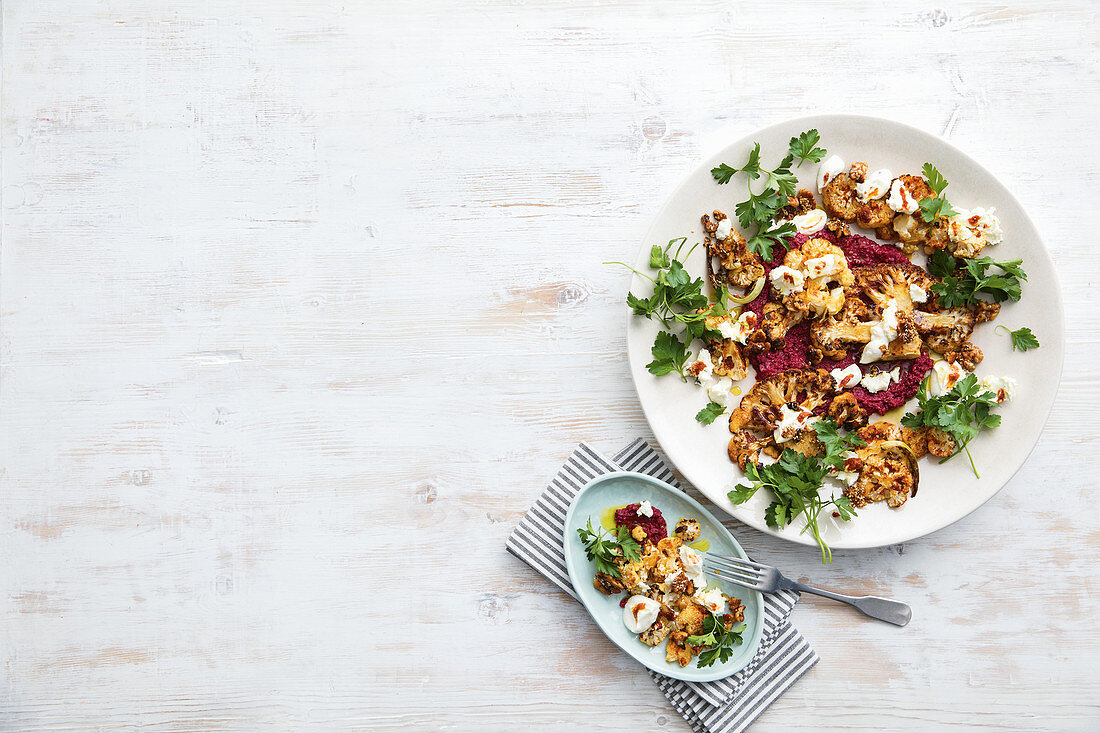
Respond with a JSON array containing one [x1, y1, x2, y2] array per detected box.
[[0, 0, 1100, 731]]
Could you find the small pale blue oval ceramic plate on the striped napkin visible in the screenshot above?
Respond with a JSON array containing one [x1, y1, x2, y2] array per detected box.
[[565, 471, 763, 682]]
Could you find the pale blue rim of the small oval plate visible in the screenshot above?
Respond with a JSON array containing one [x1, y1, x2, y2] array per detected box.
[[562, 471, 765, 682]]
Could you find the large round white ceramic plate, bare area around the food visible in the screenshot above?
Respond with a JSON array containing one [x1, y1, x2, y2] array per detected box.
[[624, 114, 1064, 548]]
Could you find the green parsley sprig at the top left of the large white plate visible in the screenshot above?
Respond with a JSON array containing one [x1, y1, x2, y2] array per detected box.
[[711, 130, 828, 260]]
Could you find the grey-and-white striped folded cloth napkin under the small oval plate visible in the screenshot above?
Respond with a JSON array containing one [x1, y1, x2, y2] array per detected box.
[[507, 438, 817, 733]]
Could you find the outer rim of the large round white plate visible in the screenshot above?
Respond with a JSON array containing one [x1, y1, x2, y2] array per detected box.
[[625, 113, 1066, 554]]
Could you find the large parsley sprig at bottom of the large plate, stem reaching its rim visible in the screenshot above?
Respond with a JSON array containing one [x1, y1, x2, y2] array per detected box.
[[728, 418, 866, 564]]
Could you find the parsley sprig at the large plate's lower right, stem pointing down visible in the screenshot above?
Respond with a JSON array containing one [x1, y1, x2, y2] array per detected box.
[[901, 374, 1001, 479]]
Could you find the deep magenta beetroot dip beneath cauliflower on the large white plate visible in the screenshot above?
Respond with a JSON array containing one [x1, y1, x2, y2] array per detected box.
[[743, 231, 932, 411]]
